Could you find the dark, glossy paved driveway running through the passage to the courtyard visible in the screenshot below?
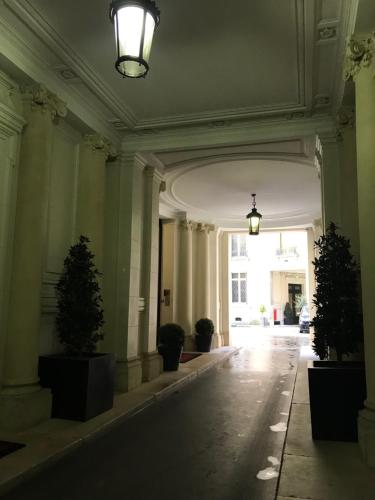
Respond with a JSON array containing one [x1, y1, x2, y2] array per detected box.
[[3, 328, 308, 500]]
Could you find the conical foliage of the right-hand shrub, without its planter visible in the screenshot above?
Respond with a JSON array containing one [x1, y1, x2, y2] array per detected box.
[[312, 222, 363, 361]]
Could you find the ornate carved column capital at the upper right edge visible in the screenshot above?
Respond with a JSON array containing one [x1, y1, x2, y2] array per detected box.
[[344, 31, 375, 81]]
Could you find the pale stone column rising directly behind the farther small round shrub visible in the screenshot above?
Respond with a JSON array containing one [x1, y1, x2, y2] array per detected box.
[[194, 223, 211, 323]]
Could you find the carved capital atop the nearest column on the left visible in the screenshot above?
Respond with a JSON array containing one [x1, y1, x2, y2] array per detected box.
[[21, 83, 67, 120]]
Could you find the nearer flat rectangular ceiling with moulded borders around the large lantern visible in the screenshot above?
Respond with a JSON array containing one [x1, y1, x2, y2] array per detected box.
[[4, 0, 356, 130]]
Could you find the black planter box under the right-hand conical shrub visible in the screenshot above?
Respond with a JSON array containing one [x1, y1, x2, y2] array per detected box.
[[308, 361, 366, 441]]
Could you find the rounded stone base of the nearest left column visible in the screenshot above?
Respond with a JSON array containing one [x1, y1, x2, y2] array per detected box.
[[0, 385, 52, 432]]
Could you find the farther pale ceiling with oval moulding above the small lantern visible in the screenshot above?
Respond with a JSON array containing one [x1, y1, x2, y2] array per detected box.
[[158, 141, 321, 229]]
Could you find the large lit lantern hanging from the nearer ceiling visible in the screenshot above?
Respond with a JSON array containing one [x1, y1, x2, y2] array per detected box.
[[109, 0, 160, 78]]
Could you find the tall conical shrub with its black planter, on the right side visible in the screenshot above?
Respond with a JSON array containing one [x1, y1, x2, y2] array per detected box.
[[308, 222, 366, 441]]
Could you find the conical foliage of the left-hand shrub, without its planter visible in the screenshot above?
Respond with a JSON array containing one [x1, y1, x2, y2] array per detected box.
[[56, 236, 104, 355]]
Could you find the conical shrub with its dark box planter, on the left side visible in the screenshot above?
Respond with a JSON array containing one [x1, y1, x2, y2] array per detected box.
[[39, 236, 115, 421]]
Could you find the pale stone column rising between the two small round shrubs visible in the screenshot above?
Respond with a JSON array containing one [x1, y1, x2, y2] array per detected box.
[[177, 220, 193, 350]]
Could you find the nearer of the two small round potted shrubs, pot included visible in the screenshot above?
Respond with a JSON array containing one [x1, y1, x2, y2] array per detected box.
[[158, 323, 185, 371]]
